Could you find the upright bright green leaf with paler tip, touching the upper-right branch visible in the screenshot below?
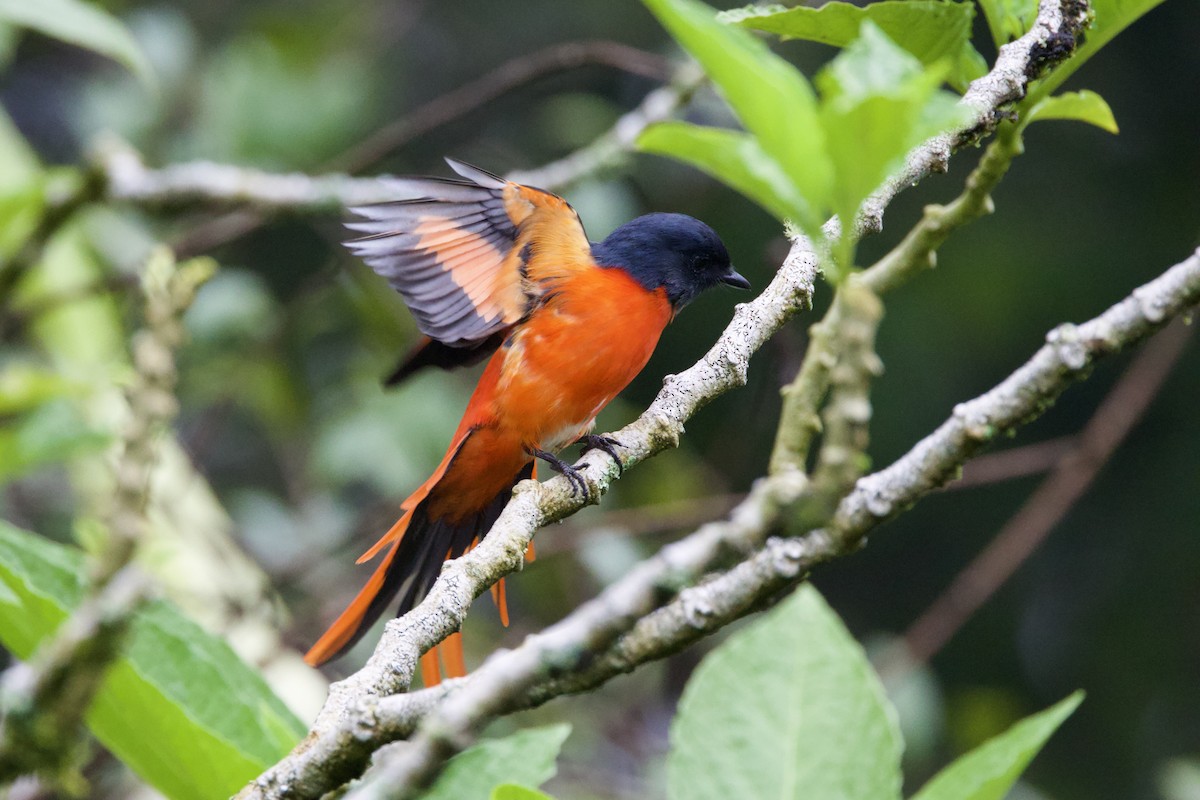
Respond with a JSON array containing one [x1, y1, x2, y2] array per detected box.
[[817, 20, 966, 261]]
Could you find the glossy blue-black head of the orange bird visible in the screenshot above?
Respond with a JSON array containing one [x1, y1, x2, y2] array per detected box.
[[592, 213, 750, 311]]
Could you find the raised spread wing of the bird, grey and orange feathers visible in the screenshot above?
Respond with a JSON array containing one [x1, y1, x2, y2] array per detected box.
[[347, 158, 594, 348]]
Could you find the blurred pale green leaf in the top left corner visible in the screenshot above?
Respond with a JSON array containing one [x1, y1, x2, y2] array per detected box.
[[0, 0, 155, 88]]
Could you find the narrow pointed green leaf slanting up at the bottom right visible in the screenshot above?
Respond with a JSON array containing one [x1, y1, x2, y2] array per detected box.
[[912, 692, 1084, 800]]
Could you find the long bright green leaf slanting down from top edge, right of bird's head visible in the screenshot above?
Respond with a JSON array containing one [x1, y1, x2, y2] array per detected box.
[[643, 0, 833, 236]]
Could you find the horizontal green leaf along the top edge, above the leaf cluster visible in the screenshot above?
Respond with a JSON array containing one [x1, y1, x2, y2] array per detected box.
[[720, 0, 988, 91]]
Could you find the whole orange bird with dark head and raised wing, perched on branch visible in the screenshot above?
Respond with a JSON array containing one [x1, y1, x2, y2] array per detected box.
[[305, 158, 750, 684]]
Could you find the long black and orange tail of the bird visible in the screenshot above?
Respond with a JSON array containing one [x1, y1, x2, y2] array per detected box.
[[304, 450, 534, 682]]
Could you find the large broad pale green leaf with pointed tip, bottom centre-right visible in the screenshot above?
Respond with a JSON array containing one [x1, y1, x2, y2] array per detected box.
[[667, 585, 902, 800]]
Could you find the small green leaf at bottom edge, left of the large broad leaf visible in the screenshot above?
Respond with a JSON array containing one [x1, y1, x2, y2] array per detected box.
[[421, 724, 571, 800]]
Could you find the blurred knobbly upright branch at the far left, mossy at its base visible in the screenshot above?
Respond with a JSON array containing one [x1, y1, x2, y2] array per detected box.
[[0, 251, 212, 788]]
